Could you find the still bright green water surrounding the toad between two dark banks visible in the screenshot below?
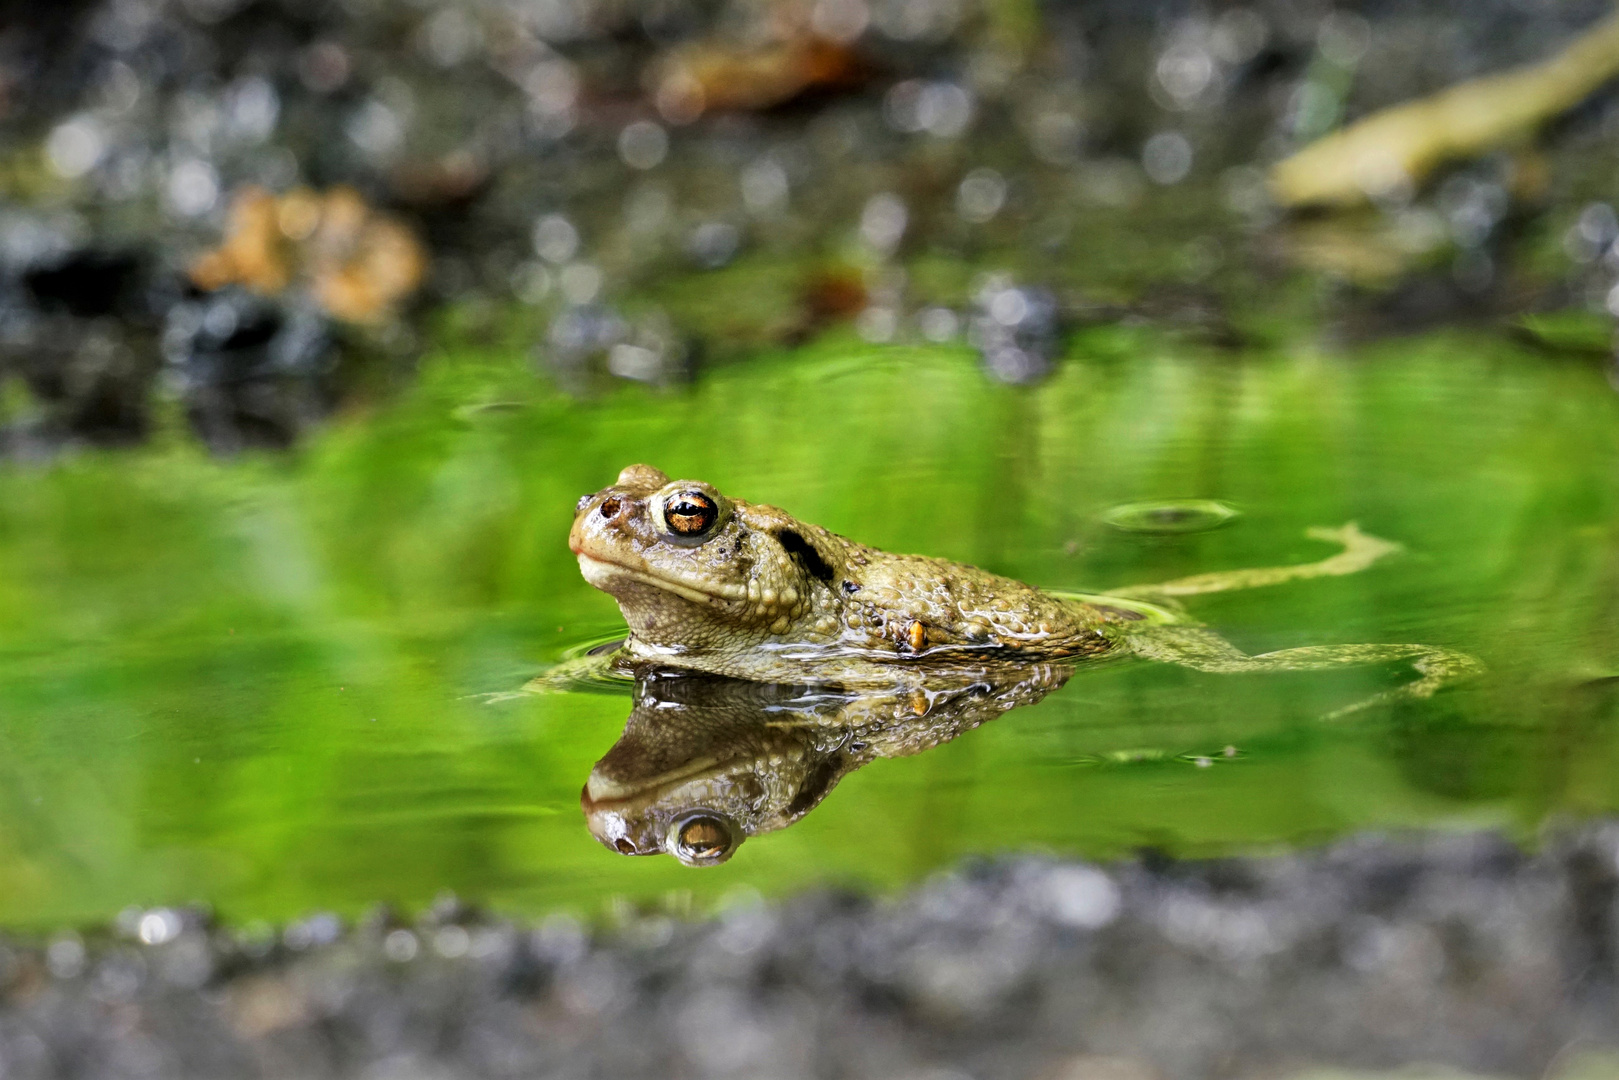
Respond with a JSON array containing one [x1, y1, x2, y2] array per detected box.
[[0, 320, 1619, 926]]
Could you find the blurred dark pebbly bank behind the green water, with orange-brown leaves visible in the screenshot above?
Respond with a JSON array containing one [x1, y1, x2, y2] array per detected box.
[[0, 0, 1616, 446]]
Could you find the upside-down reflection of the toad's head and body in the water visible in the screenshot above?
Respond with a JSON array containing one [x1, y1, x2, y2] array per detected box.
[[580, 664, 1072, 866]]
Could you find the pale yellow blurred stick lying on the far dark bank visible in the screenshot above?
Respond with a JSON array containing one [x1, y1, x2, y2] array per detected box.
[[1269, 13, 1619, 206]]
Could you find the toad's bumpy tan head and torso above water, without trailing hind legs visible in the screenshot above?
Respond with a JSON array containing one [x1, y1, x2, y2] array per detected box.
[[568, 465, 1140, 682]]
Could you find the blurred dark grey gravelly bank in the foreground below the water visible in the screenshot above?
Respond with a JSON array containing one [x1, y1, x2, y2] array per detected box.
[[0, 823, 1619, 1080]]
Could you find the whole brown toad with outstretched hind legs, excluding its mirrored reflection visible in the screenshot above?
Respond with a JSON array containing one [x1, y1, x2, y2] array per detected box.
[[568, 465, 1478, 698]]
